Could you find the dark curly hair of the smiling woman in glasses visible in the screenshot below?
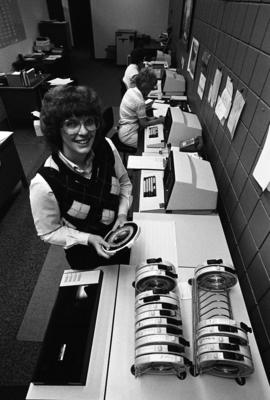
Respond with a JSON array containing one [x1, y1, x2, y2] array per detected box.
[[40, 86, 102, 151]]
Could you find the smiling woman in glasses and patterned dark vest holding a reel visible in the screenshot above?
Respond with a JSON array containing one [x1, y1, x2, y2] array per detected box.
[[30, 86, 132, 269]]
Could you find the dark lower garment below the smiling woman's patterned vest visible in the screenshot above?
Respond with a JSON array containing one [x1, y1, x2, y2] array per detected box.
[[65, 244, 130, 270]]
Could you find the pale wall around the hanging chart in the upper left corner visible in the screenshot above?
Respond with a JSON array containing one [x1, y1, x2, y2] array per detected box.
[[0, 0, 49, 72]]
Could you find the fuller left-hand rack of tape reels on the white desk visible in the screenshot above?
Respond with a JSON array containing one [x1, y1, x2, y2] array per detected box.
[[131, 258, 191, 379]]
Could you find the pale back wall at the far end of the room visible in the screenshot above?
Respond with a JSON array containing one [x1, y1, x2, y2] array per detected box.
[[89, 0, 170, 58]]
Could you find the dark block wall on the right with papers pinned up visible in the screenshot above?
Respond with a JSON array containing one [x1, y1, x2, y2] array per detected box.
[[170, 0, 270, 379]]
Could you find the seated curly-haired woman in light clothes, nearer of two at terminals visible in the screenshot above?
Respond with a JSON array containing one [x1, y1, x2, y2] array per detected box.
[[118, 68, 164, 148]]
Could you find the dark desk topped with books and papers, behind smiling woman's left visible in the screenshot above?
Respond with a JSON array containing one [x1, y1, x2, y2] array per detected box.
[[0, 74, 50, 129]]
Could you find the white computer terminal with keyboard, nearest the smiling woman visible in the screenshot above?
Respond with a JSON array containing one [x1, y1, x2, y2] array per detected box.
[[139, 147, 218, 214]]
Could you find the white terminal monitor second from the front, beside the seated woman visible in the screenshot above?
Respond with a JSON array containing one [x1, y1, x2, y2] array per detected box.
[[164, 107, 202, 147]]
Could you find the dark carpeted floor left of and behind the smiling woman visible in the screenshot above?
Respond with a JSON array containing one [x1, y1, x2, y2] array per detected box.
[[0, 51, 124, 400]]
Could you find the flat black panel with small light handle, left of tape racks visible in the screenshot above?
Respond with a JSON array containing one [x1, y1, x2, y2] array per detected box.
[[33, 271, 102, 385]]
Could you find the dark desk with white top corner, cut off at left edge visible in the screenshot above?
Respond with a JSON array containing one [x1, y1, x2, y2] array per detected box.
[[0, 132, 28, 206]]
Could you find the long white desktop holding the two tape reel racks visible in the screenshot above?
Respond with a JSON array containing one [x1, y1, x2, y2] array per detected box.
[[27, 214, 270, 400]]
